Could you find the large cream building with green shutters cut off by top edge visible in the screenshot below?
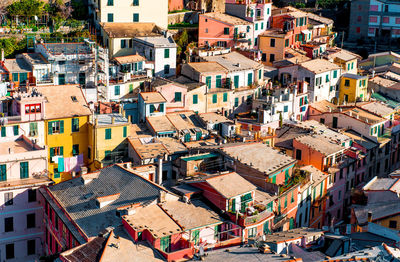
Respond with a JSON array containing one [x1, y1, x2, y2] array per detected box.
[[88, 0, 168, 28]]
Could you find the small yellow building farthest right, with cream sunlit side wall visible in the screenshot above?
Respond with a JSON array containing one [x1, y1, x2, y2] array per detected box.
[[339, 74, 369, 104]]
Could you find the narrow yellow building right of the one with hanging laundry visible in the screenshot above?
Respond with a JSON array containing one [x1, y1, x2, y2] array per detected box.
[[88, 114, 130, 170]]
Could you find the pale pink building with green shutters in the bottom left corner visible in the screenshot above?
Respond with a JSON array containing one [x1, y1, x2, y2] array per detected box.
[[0, 135, 51, 261]]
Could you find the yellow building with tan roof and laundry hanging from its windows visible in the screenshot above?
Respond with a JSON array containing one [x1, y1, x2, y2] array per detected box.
[[37, 85, 91, 183]]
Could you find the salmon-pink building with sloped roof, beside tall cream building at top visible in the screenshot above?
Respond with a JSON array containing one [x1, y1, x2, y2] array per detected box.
[[199, 13, 254, 48]]
